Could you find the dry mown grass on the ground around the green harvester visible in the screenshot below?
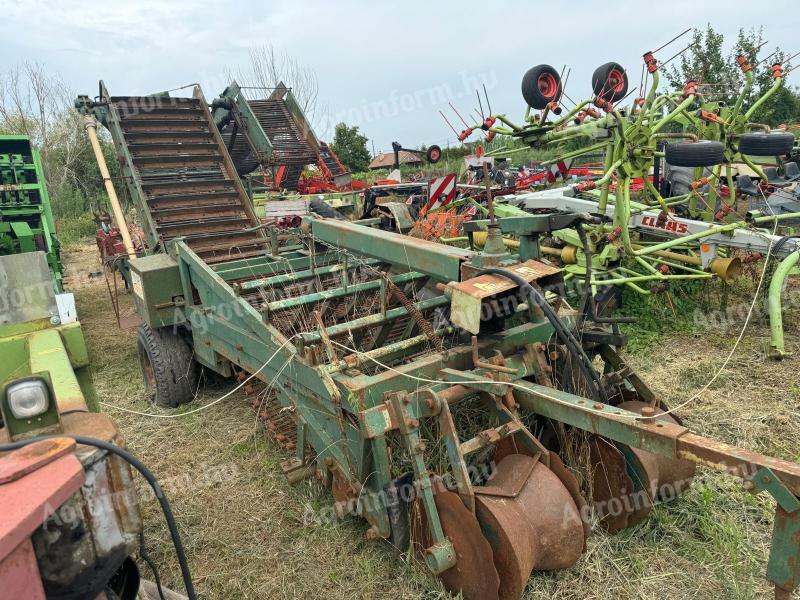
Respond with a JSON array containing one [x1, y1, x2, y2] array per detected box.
[[61, 246, 800, 600]]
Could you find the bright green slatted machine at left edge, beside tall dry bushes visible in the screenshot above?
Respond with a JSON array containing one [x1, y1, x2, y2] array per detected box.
[[0, 135, 62, 292]]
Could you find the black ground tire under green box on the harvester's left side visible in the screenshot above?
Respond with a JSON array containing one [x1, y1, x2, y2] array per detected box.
[[136, 324, 198, 408]]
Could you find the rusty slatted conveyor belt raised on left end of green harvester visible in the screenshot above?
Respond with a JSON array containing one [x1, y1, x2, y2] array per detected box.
[[104, 96, 266, 263]]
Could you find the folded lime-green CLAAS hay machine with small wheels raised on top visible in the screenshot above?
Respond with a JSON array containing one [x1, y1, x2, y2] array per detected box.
[[450, 47, 800, 358]]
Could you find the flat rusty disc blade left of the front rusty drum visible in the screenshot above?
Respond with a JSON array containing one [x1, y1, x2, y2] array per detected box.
[[414, 485, 500, 600]]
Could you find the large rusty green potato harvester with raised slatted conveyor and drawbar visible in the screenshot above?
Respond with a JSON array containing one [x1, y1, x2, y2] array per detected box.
[[78, 84, 800, 599]]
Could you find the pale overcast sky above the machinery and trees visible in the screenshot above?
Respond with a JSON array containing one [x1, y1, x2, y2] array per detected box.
[[0, 0, 800, 151]]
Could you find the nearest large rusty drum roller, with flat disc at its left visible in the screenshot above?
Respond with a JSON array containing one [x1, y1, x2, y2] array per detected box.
[[475, 454, 585, 600]]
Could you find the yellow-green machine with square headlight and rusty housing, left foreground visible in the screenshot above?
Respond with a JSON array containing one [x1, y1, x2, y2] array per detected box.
[[0, 250, 147, 600]]
